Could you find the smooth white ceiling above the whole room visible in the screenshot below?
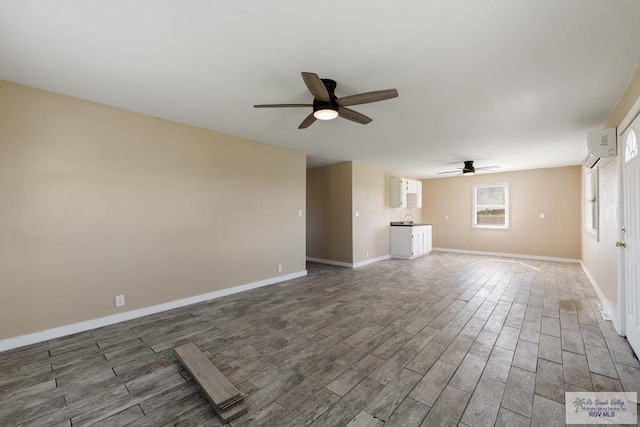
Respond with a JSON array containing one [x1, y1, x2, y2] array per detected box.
[[0, 0, 640, 178]]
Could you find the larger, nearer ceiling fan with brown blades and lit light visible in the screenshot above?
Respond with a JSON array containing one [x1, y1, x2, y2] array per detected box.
[[254, 72, 398, 129]]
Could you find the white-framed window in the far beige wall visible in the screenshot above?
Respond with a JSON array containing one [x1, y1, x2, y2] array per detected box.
[[473, 184, 509, 229]]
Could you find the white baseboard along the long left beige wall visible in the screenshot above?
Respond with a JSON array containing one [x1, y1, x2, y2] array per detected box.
[[0, 270, 307, 352]]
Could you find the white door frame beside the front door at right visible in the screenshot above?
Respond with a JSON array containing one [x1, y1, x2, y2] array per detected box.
[[616, 94, 640, 336]]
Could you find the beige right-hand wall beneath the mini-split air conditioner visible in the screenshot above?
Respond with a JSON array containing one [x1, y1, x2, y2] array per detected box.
[[582, 64, 640, 332]]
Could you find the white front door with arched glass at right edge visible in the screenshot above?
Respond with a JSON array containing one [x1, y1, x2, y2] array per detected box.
[[621, 121, 640, 354]]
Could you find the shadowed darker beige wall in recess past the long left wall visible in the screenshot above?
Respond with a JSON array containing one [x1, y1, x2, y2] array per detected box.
[[307, 162, 353, 264]]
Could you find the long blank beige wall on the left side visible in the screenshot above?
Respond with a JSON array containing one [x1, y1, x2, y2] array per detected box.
[[0, 81, 306, 339]]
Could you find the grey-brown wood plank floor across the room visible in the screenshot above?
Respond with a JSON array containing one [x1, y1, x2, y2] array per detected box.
[[0, 252, 640, 427]]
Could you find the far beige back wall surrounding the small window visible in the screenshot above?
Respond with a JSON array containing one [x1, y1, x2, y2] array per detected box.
[[422, 166, 581, 260]]
